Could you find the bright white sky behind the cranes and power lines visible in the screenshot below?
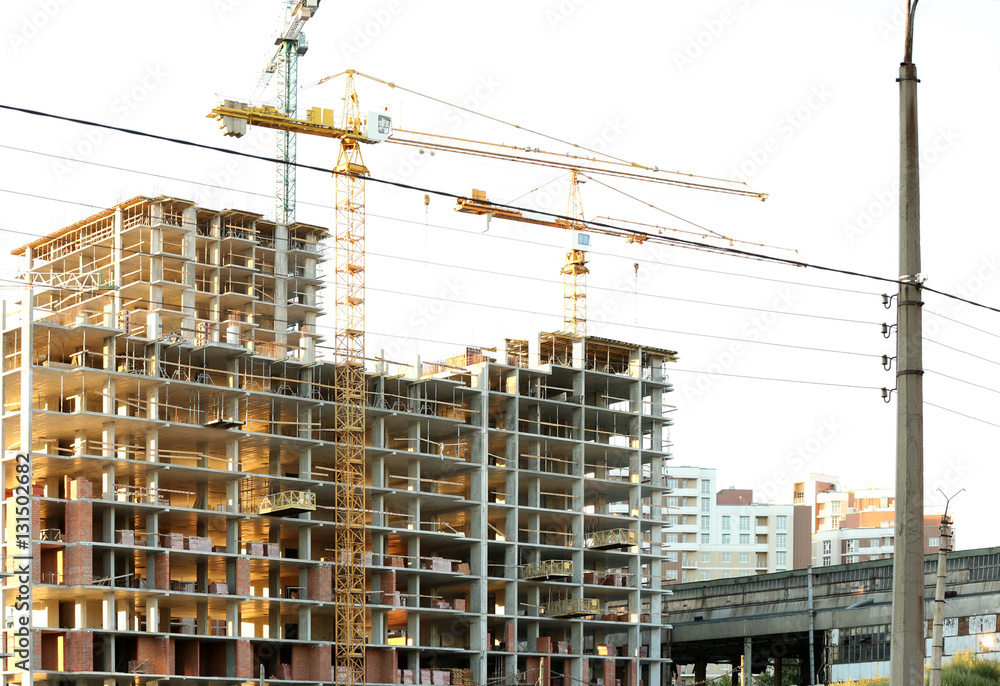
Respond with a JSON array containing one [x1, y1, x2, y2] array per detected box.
[[0, 0, 1000, 548]]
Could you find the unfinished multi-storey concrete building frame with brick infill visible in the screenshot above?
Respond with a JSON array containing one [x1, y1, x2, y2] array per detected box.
[[2, 197, 676, 686]]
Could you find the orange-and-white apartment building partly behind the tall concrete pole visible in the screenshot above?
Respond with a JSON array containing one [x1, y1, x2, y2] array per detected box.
[[794, 474, 944, 567]]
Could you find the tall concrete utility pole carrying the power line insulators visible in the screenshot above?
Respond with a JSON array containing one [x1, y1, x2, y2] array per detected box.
[[889, 0, 924, 686]]
